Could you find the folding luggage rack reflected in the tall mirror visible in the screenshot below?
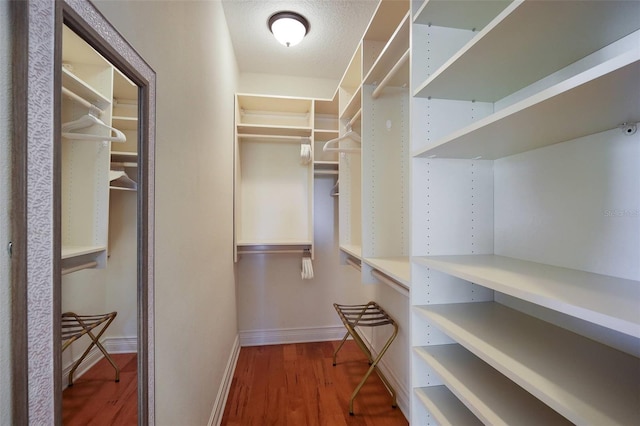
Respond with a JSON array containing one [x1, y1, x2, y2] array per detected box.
[[61, 312, 120, 386]]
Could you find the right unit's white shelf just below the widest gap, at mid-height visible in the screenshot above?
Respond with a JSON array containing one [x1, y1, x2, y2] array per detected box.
[[413, 255, 640, 337]]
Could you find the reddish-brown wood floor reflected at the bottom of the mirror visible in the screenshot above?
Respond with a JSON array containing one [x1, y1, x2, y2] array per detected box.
[[62, 354, 138, 426]]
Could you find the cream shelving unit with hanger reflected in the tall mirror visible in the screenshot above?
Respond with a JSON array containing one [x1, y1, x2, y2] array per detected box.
[[61, 26, 113, 273]]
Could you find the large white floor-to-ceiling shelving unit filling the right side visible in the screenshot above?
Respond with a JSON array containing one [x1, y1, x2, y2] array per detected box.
[[410, 0, 640, 425]]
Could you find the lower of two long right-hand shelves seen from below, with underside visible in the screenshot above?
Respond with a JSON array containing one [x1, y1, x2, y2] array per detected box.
[[412, 49, 640, 159]]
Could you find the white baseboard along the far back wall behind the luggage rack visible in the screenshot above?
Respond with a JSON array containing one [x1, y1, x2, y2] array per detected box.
[[240, 326, 346, 346]]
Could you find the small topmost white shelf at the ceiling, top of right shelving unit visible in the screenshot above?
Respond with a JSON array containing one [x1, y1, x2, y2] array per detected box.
[[413, 0, 512, 31]]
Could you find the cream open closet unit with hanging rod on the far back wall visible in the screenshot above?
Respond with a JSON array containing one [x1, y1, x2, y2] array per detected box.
[[235, 94, 316, 260]]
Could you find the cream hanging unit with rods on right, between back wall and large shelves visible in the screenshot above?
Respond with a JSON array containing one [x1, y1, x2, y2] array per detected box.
[[338, 1, 410, 289]]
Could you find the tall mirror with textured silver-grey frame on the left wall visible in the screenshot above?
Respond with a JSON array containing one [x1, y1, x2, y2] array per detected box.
[[12, 0, 155, 425]]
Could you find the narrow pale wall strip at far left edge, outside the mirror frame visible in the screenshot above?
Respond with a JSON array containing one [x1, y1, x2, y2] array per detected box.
[[0, 0, 12, 425]]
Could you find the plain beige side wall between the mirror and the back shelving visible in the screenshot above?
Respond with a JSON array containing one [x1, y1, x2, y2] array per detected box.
[[96, 1, 238, 425]]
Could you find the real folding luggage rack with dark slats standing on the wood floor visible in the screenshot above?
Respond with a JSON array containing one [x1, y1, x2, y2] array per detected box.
[[333, 302, 398, 416]]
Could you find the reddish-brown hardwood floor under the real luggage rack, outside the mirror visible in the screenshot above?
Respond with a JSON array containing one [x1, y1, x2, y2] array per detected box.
[[222, 341, 409, 426]]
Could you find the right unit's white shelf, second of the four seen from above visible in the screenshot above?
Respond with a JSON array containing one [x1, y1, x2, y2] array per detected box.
[[415, 302, 640, 425]]
